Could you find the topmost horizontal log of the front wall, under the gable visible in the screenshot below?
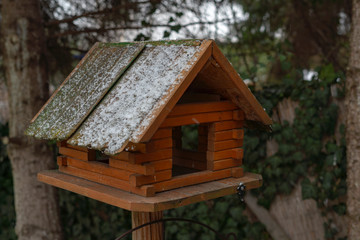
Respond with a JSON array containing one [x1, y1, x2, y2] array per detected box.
[[168, 101, 238, 117]]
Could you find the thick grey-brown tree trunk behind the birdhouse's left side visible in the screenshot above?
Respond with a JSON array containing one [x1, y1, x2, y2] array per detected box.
[[1, 0, 62, 240]]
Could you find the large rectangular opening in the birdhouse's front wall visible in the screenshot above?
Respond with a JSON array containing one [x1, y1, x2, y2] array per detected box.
[[172, 124, 207, 176]]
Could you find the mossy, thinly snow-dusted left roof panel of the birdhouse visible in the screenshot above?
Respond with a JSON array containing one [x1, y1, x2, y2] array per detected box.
[[27, 44, 144, 140]]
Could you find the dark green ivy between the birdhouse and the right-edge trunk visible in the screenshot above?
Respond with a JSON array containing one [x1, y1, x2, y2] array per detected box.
[[244, 65, 346, 238]]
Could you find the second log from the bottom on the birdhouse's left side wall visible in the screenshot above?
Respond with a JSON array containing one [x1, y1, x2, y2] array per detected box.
[[67, 157, 134, 181]]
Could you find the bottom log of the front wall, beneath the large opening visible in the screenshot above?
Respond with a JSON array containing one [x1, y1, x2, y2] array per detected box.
[[153, 169, 232, 192]]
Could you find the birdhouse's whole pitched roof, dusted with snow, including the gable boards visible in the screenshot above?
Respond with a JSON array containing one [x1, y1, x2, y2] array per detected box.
[[26, 40, 271, 155]]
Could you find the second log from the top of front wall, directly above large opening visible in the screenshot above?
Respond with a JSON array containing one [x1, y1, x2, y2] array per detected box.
[[160, 111, 233, 128]]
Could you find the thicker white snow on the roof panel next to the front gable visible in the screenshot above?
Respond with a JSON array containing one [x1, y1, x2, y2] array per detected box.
[[68, 44, 200, 155]]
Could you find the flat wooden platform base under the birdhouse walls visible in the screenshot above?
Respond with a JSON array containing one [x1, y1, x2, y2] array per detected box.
[[38, 170, 262, 212]]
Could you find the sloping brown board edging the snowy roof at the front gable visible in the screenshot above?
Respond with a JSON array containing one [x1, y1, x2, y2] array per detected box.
[[139, 40, 213, 142]]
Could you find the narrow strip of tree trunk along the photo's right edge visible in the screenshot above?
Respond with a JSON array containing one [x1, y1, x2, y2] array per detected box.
[[345, 0, 360, 240]]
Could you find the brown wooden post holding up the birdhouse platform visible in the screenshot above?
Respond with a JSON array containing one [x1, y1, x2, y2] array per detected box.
[[131, 211, 164, 240]]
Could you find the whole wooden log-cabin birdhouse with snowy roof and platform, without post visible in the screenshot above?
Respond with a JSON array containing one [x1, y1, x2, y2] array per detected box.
[[26, 40, 271, 212]]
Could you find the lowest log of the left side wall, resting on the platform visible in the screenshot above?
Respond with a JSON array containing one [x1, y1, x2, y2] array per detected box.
[[59, 166, 155, 197]]
